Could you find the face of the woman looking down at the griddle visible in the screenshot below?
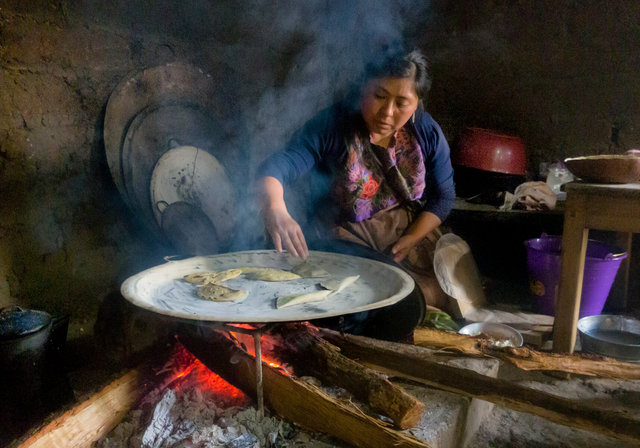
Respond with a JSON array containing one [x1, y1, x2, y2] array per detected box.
[[360, 78, 418, 141]]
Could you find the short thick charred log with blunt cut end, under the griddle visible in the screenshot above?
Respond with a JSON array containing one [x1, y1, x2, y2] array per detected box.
[[278, 324, 424, 429]]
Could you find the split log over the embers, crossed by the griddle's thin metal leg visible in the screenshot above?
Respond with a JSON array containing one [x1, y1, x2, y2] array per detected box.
[[179, 328, 428, 448]]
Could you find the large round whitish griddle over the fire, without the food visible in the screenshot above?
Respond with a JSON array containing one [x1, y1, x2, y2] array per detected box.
[[121, 250, 415, 322]]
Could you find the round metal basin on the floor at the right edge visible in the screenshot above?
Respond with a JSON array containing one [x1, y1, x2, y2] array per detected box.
[[578, 314, 640, 362]]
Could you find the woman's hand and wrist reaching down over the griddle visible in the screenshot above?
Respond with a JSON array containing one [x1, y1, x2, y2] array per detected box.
[[260, 177, 309, 258]]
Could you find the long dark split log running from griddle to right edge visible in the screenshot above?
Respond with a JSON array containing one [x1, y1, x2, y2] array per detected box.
[[319, 329, 640, 443]]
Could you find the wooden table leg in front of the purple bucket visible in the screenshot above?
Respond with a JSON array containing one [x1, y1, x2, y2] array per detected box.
[[553, 195, 589, 353]]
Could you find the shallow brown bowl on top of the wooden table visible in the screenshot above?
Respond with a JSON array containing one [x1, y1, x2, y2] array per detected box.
[[564, 154, 640, 184]]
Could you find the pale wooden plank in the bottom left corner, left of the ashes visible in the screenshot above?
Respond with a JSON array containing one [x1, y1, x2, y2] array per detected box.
[[20, 369, 145, 448]]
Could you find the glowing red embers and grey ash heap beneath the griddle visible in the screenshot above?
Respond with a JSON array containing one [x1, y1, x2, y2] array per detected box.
[[95, 342, 324, 448]]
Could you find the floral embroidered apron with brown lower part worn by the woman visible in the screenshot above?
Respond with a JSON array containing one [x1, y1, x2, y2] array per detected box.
[[333, 124, 447, 308]]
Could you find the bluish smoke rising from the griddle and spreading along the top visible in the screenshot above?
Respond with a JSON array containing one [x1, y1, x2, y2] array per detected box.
[[69, 0, 429, 254]]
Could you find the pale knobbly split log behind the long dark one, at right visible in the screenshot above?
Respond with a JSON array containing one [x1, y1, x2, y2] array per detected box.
[[413, 328, 640, 380]]
